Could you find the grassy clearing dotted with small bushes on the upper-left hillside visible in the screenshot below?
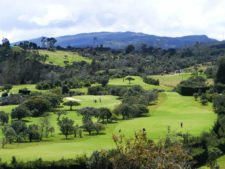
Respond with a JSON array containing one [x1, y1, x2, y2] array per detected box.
[[39, 50, 91, 67]]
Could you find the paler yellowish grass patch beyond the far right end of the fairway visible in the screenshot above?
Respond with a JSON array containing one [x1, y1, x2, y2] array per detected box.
[[150, 73, 191, 87]]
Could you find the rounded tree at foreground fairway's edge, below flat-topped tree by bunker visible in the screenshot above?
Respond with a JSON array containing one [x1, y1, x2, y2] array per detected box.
[[58, 117, 74, 139]]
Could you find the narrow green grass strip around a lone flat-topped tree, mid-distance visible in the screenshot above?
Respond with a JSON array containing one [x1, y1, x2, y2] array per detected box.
[[108, 76, 172, 90]]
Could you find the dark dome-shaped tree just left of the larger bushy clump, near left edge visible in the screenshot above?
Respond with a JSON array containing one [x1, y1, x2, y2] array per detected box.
[[11, 105, 31, 120]]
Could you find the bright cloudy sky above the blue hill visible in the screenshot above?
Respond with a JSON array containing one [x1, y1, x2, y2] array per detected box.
[[0, 0, 225, 42]]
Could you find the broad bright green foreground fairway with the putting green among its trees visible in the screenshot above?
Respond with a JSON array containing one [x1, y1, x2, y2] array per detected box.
[[0, 92, 216, 161]]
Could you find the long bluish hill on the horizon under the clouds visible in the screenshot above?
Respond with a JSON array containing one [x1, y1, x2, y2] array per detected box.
[[18, 32, 218, 49]]
